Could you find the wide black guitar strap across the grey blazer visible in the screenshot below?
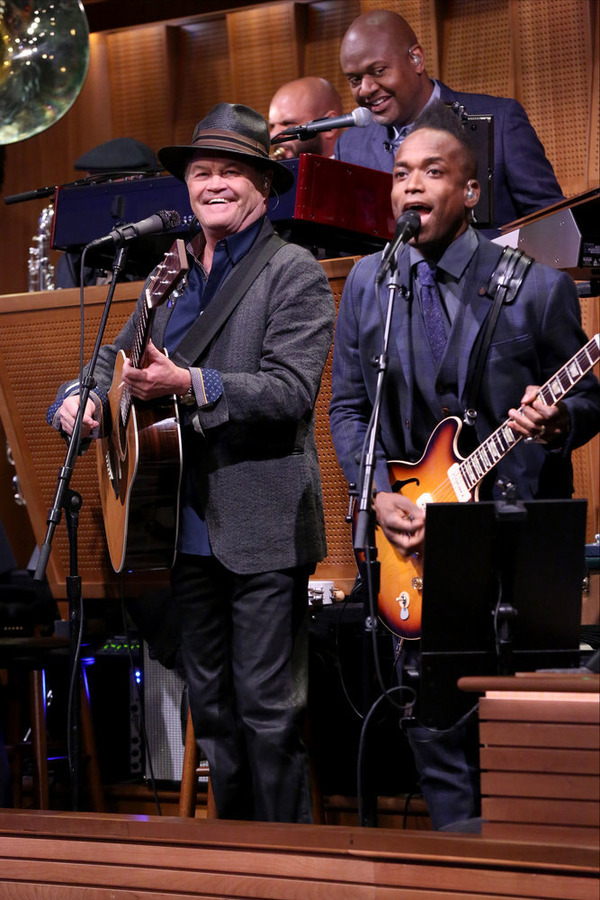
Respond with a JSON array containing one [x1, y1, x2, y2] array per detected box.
[[171, 234, 285, 367]]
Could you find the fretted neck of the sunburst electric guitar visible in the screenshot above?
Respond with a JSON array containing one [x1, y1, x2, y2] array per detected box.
[[458, 334, 600, 491]]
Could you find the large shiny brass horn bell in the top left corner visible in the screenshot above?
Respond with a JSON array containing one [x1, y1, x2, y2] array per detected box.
[[0, 0, 89, 145]]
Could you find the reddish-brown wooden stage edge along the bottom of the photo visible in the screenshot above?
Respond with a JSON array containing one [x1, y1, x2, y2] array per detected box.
[[0, 810, 599, 900]]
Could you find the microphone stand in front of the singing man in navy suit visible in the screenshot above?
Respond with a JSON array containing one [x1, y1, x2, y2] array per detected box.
[[353, 254, 400, 827]]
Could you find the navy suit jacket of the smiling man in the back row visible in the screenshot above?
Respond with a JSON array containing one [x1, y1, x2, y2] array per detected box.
[[335, 82, 563, 229]]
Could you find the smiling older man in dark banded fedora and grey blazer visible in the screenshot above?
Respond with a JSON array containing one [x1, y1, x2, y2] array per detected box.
[[52, 103, 335, 822]]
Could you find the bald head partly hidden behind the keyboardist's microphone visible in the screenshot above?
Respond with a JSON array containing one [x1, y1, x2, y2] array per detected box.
[[269, 75, 342, 159]]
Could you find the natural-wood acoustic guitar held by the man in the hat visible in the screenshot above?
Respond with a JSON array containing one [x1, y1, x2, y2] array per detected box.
[[97, 239, 188, 572]]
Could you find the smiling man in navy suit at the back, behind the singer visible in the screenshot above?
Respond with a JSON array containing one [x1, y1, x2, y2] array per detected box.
[[335, 10, 563, 230]]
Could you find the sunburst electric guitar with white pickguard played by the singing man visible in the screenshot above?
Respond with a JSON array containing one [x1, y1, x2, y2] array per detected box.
[[375, 334, 600, 640]]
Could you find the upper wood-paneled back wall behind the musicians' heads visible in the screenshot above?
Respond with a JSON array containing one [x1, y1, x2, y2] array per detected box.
[[0, 0, 600, 294]]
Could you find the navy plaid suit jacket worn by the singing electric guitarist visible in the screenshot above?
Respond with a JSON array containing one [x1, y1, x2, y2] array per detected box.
[[330, 229, 600, 499]]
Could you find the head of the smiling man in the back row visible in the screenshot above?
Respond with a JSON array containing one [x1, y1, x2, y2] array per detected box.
[[340, 9, 433, 128]]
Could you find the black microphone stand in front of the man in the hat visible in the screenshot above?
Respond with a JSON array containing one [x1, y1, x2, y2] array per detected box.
[[33, 239, 127, 811]]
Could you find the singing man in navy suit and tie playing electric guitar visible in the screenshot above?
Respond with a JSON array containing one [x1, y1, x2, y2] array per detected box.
[[330, 103, 600, 828]]
